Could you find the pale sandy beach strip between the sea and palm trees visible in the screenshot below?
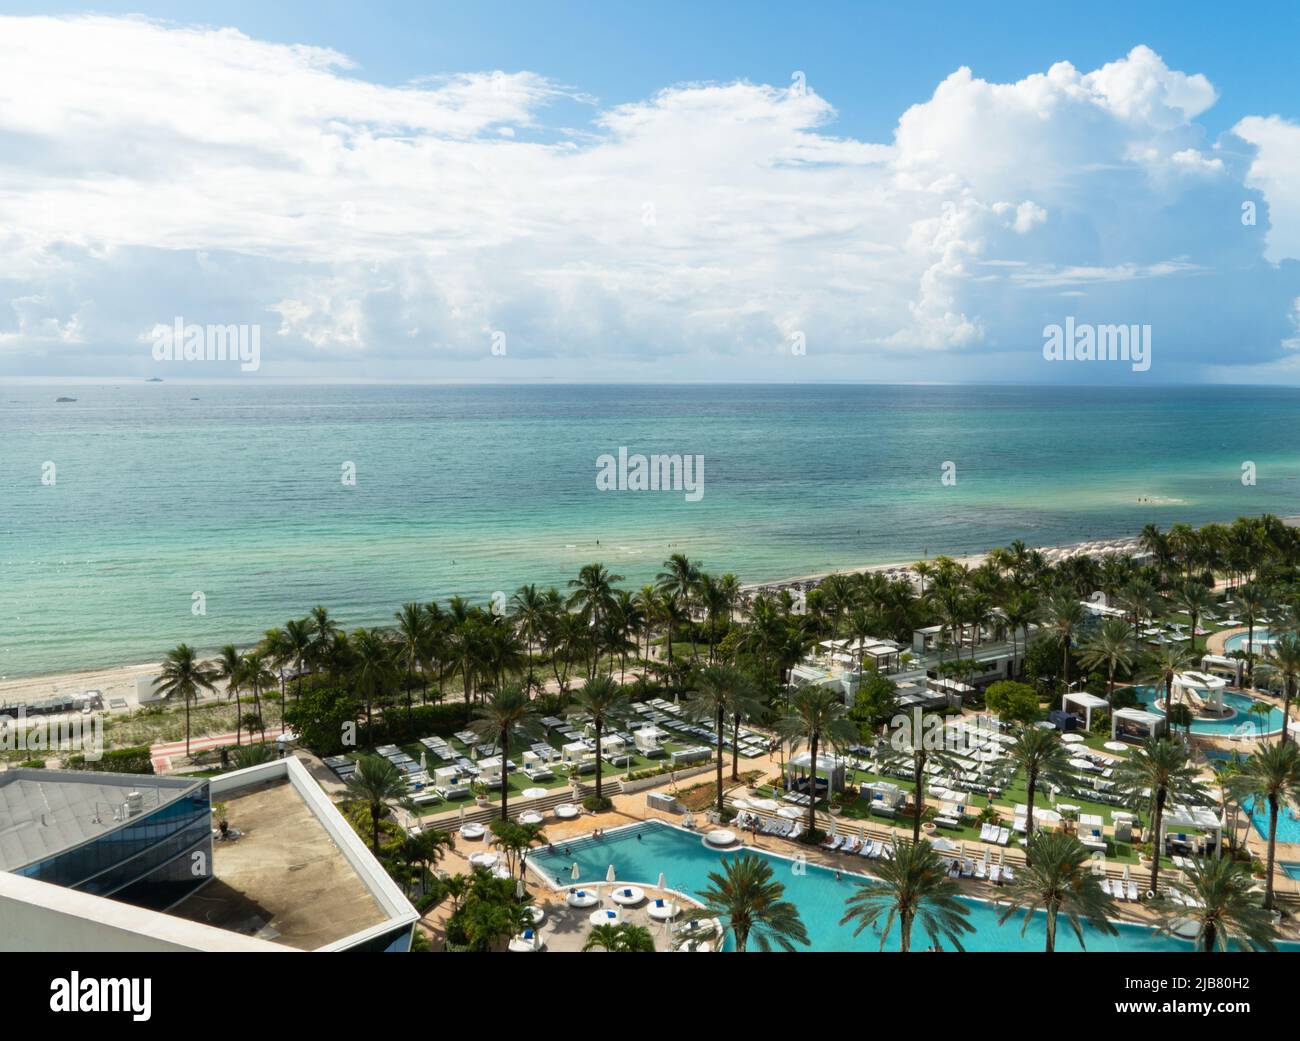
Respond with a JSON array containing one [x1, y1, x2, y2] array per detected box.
[[0, 515, 1300, 706]]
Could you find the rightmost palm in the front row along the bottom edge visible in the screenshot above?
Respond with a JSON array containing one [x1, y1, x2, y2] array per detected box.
[[1152, 856, 1277, 954]]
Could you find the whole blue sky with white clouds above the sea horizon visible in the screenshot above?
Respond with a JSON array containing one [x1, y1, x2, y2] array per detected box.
[[0, 3, 1300, 385]]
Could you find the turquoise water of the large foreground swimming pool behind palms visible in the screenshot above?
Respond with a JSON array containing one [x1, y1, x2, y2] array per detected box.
[[528, 821, 1190, 951]]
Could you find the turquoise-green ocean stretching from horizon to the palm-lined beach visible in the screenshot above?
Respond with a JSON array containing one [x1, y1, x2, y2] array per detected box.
[[0, 382, 1300, 676]]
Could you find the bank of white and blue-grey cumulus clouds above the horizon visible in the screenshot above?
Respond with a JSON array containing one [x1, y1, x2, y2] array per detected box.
[[0, 17, 1300, 379]]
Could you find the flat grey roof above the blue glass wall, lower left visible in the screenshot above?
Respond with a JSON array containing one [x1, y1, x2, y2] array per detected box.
[[0, 768, 203, 871]]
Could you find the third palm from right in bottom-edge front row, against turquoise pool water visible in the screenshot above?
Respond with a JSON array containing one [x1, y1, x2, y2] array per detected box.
[[840, 838, 975, 954]]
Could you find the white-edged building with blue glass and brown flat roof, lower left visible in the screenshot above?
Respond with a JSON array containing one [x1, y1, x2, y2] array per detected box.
[[0, 756, 419, 951]]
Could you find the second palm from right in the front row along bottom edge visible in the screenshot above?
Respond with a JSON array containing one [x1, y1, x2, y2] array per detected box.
[[998, 832, 1118, 954]]
